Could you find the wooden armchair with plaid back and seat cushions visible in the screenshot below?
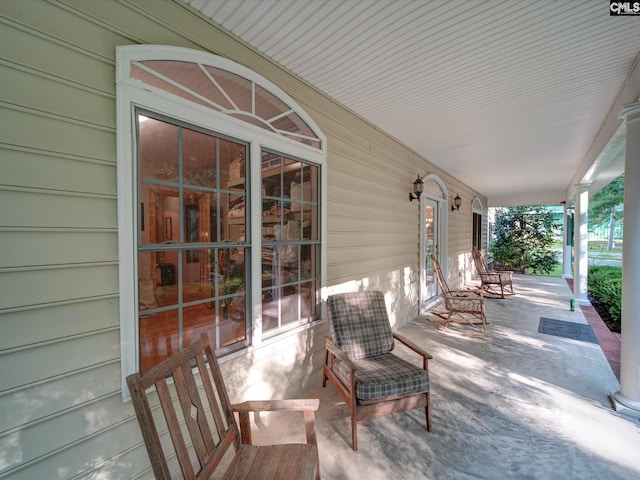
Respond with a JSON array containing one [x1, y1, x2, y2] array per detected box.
[[322, 291, 432, 450]]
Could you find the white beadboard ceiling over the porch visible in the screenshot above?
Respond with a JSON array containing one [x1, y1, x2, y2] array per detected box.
[[182, 0, 640, 206]]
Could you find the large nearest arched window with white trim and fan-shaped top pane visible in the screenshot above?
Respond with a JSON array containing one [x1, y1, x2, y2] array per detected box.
[[117, 46, 326, 391]]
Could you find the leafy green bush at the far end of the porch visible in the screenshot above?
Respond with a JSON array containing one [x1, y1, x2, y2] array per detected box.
[[490, 206, 560, 273]]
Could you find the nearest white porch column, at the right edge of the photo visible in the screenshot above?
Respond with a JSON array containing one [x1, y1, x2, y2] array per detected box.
[[612, 102, 640, 418]]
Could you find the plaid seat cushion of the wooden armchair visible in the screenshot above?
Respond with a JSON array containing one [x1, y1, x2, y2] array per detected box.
[[334, 353, 429, 400]]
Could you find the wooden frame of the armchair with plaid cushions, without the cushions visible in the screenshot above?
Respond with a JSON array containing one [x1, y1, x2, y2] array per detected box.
[[322, 290, 433, 451]]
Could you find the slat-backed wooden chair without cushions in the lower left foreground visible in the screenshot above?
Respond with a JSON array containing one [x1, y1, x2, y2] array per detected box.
[[127, 333, 320, 480]]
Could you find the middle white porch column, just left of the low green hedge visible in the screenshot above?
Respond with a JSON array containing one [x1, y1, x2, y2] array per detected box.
[[573, 184, 591, 305]]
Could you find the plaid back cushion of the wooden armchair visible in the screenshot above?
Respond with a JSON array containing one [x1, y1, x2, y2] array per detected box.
[[328, 292, 393, 360]]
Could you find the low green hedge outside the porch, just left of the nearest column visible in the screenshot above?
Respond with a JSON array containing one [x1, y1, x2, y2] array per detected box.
[[587, 265, 622, 332]]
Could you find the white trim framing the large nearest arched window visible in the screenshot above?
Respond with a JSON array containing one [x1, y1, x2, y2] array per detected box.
[[116, 45, 327, 400]]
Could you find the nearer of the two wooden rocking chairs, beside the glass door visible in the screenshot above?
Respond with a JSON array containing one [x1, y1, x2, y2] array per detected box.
[[430, 254, 488, 336]]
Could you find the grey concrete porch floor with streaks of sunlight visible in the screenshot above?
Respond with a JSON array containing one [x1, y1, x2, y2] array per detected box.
[[259, 276, 640, 480]]
